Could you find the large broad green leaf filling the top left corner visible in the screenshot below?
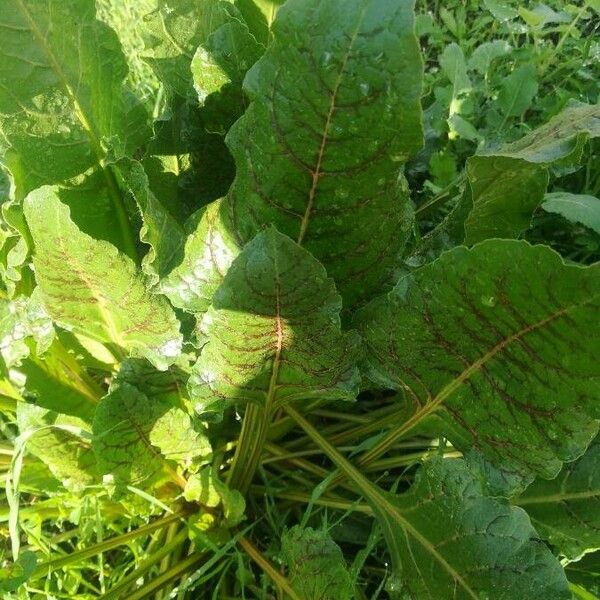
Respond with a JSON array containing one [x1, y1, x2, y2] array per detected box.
[[0, 0, 150, 197]]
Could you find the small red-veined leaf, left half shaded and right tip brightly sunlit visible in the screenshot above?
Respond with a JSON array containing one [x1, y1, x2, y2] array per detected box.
[[93, 382, 211, 485]]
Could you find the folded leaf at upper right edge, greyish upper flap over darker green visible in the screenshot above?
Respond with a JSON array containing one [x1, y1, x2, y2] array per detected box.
[[465, 102, 600, 245]]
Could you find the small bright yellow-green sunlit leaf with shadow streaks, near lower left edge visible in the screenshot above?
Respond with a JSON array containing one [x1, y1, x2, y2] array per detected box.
[[17, 402, 98, 492]]
